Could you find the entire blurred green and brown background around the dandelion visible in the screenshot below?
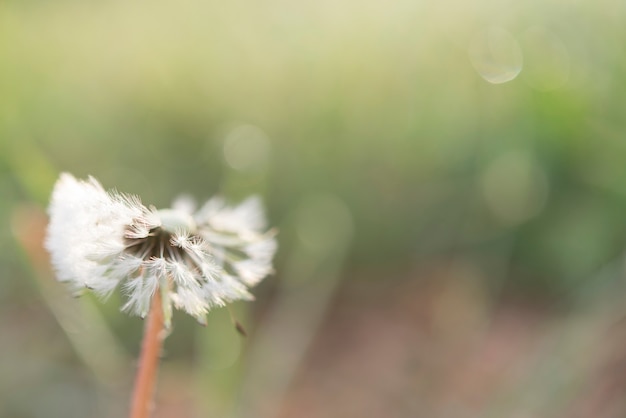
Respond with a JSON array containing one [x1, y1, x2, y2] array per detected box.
[[0, 0, 626, 418]]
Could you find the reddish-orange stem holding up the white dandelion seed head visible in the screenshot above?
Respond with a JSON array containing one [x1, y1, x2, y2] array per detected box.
[[130, 289, 164, 418]]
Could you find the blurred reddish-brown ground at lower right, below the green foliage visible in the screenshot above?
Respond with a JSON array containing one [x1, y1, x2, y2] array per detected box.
[[270, 264, 626, 418]]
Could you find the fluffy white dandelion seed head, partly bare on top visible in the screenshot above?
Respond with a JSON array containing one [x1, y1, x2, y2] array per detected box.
[[45, 173, 277, 324]]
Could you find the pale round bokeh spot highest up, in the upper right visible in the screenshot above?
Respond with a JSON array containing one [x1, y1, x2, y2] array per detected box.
[[469, 28, 523, 84]]
